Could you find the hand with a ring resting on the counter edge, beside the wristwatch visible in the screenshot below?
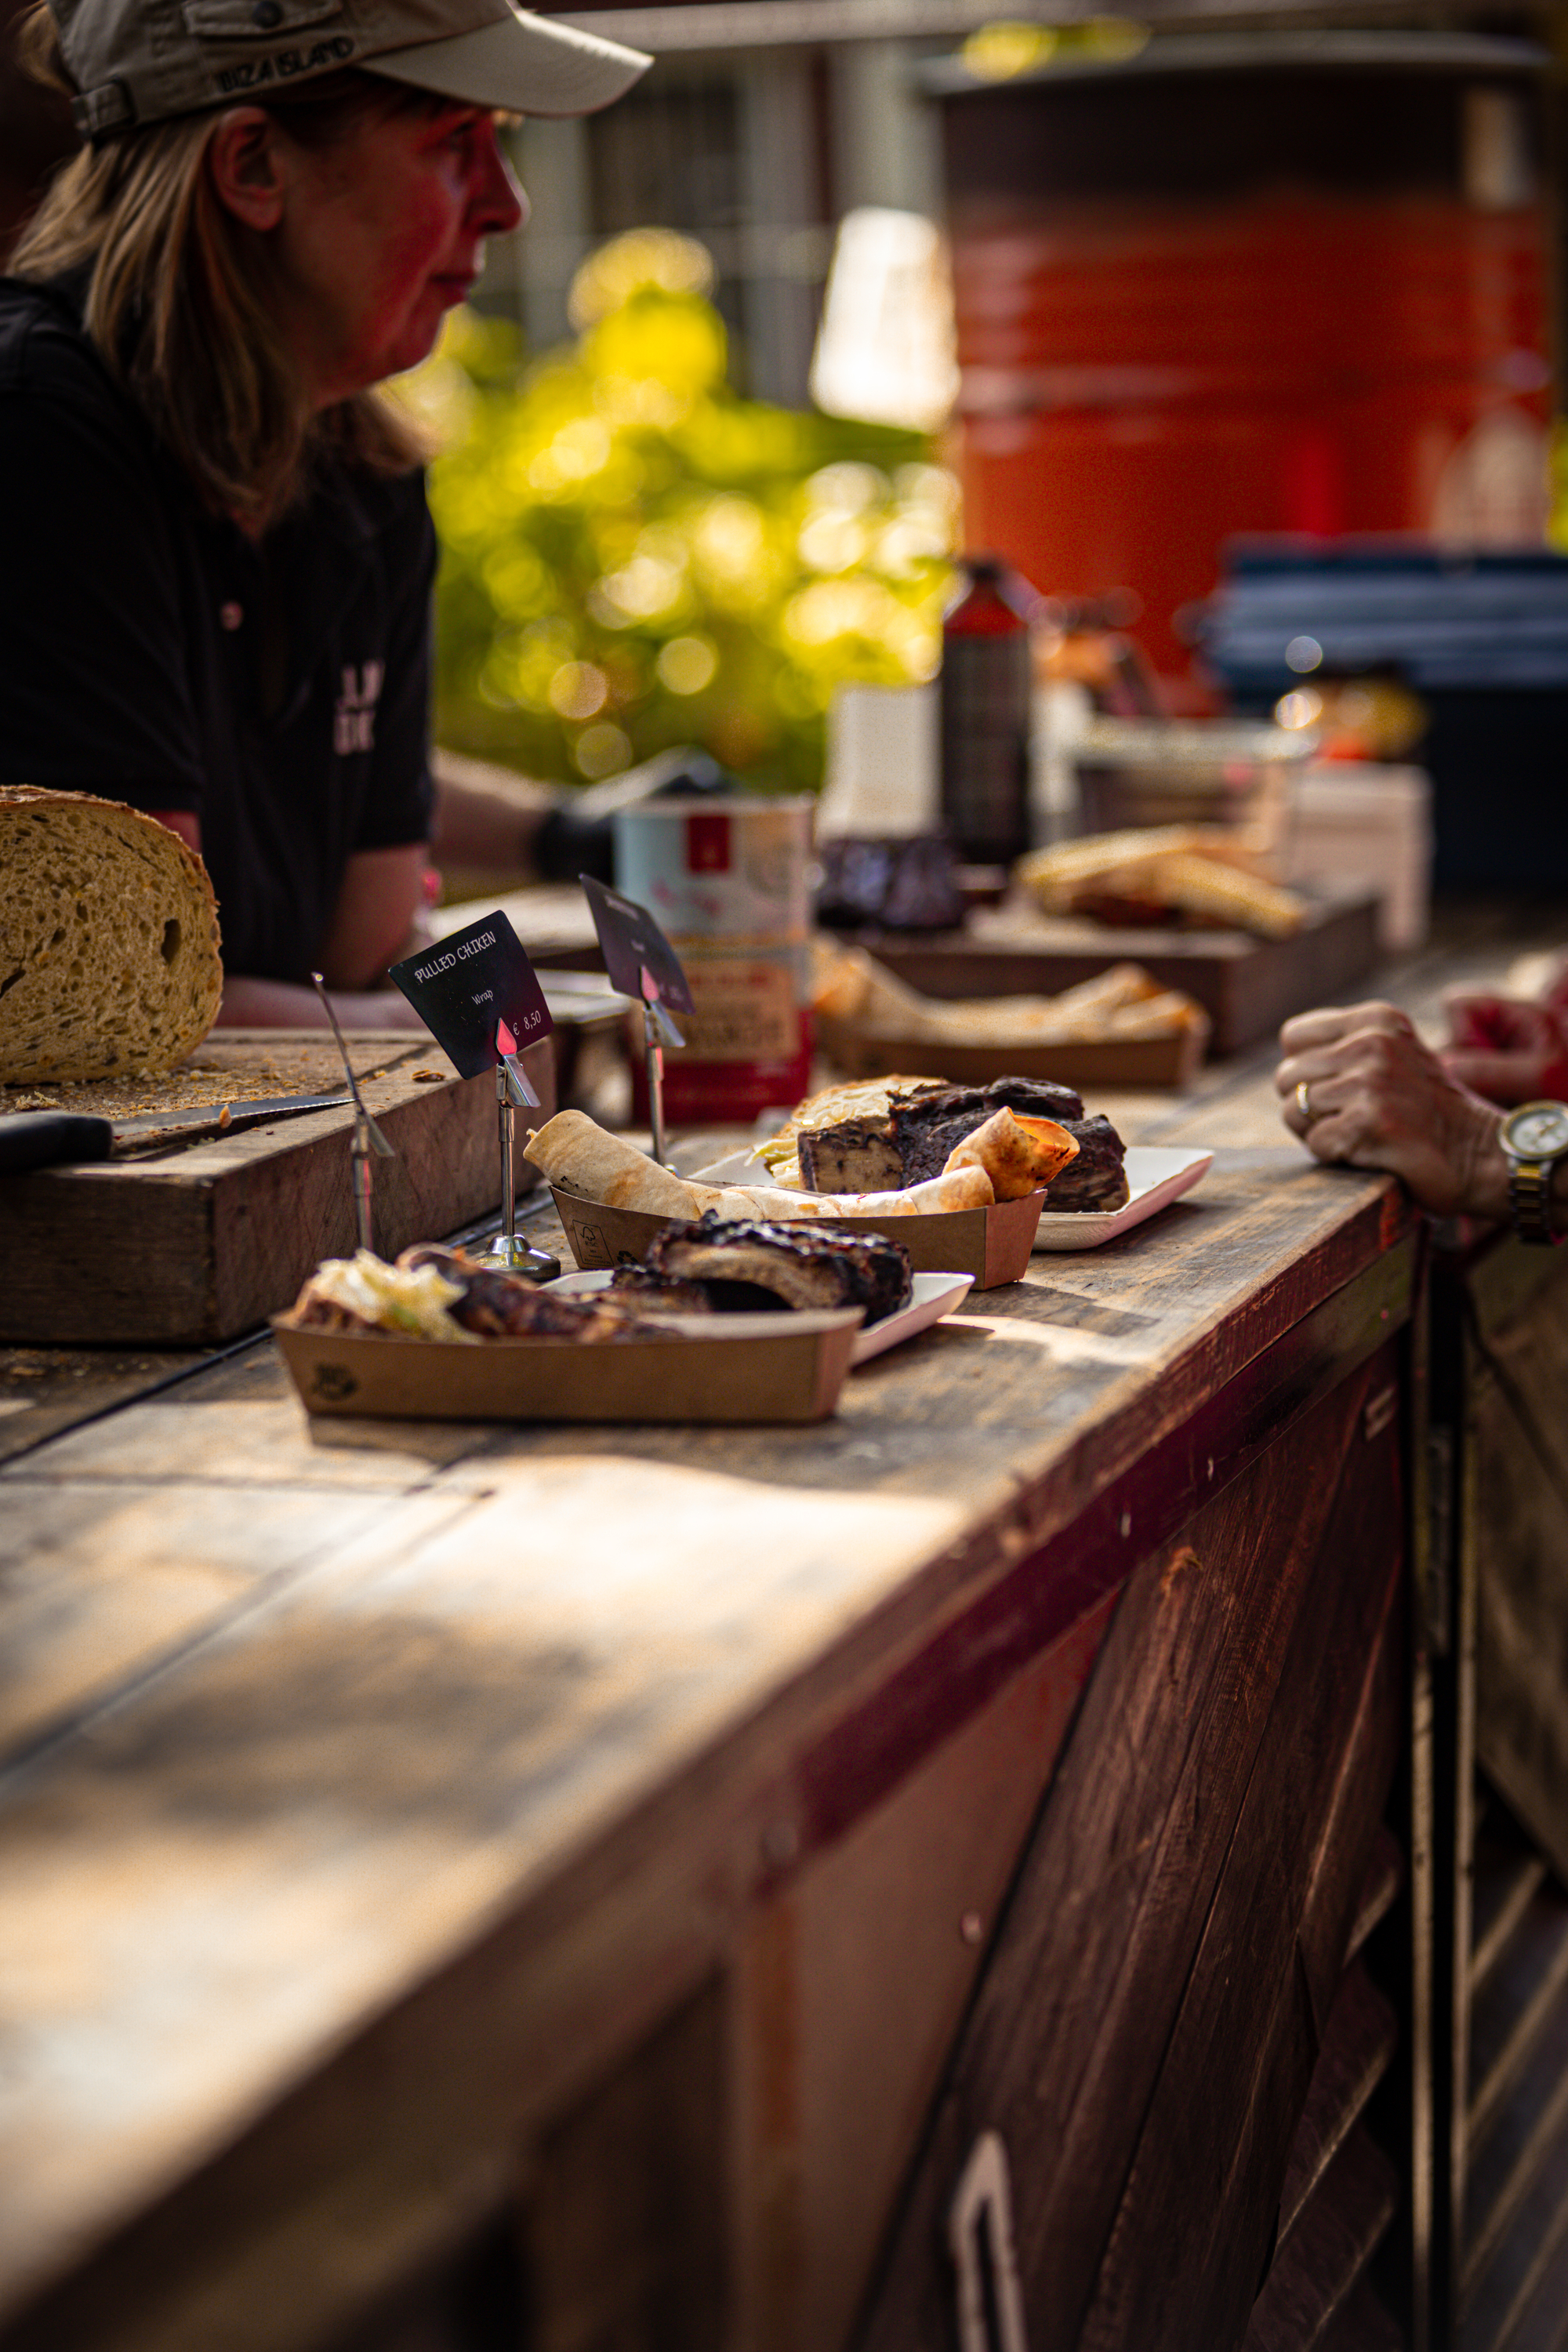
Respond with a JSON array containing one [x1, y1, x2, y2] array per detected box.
[[1274, 1002, 1507, 1221]]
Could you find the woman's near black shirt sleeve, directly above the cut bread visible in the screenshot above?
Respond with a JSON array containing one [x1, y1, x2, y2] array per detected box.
[[0, 327, 202, 814]]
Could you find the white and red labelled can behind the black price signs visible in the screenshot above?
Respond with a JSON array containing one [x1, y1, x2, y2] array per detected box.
[[616, 795, 815, 1127]]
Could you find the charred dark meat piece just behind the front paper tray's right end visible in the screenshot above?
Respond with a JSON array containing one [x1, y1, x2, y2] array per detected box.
[[644, 1209, 914, 1324]]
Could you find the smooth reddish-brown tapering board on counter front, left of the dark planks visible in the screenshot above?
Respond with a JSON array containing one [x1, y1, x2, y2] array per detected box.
[[731, 1592, 1116, 2352]]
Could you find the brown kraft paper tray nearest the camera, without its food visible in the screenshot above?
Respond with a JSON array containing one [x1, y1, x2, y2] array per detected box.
[[273, 1308, 860, 1423]]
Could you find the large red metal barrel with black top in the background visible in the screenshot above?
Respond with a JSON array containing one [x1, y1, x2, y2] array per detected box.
[[945, 35, 1549, 675]]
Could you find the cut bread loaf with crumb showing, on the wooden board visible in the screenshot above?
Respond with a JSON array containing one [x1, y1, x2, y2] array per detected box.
[[0, 783, 223, 1087]]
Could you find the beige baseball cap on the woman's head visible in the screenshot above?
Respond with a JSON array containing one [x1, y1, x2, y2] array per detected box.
[[49, 0, 654, 139]]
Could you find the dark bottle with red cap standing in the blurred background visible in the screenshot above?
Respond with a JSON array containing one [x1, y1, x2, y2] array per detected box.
[[940, 555, 1039, 866]]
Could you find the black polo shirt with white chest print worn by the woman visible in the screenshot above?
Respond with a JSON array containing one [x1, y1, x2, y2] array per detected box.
[[0, 280, 435, 981]]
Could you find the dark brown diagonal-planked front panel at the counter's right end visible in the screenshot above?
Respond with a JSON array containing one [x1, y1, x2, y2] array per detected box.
[[858, 1348, 1401, 2352]]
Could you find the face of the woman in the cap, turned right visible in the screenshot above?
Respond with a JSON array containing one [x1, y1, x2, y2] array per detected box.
[[270, 103, 529, 407]]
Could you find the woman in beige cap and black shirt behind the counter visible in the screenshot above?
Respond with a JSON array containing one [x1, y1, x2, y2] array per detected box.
[[0, 0, 649, 1025]]
